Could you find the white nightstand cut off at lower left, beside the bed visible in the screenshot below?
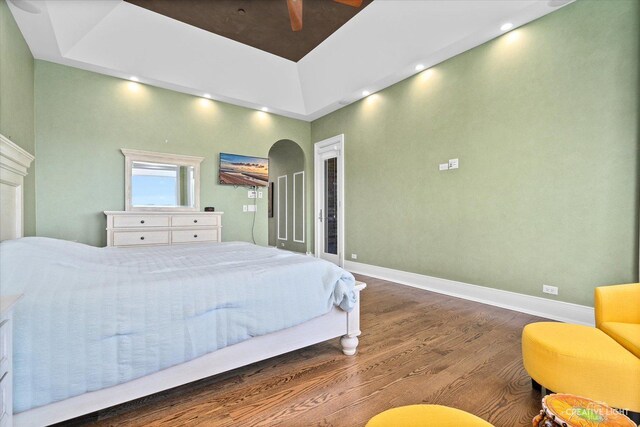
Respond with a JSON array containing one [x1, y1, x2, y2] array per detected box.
[[0, 295, 22, 427]]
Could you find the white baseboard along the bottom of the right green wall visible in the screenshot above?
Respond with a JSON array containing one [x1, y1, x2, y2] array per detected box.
[[344, 261, 595, 326]]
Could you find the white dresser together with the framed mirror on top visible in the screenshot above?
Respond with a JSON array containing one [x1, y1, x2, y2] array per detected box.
[[104, 148, 223, 247]]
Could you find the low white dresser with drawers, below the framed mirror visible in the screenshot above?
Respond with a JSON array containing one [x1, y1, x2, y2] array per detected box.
[[104, 211, 223, 247]]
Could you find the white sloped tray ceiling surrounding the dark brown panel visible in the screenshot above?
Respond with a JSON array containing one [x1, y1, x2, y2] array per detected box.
[[8, 0, 571, 121]]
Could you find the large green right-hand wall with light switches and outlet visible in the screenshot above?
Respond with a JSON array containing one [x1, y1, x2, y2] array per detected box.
[[311, 0, 640, 305]]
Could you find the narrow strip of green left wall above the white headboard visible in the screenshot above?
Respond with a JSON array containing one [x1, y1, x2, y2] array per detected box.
[[0, 0, 36, 236]]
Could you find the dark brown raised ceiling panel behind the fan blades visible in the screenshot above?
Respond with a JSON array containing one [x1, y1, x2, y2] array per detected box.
[[126, 0, 372, 62]]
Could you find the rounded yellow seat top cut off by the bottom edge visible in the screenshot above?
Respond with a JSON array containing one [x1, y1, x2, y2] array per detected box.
[[366, 405, 493, 427]]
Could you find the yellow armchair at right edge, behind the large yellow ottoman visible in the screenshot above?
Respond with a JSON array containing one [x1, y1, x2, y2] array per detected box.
[[595, 283, 640, 358]]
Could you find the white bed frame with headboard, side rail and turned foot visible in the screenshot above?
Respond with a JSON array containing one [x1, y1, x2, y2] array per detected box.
[[0, 135, 366, 427]]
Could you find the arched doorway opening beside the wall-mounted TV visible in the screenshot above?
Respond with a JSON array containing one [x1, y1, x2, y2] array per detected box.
[[268, 139, 307, 253]]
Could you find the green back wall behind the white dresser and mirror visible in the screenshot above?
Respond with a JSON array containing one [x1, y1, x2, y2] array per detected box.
[[35, 60, 313, 246]]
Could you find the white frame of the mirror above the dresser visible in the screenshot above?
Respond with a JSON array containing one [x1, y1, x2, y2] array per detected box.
[[120, 148, 204, 212]]
